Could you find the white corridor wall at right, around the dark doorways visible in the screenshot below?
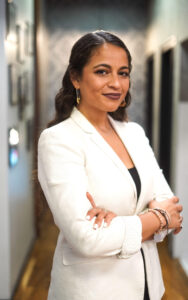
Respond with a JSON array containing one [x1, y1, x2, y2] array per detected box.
[[147, 0, 188, 274]]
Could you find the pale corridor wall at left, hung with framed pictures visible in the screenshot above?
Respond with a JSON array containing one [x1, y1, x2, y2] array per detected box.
[[0, 0, 35, 299]]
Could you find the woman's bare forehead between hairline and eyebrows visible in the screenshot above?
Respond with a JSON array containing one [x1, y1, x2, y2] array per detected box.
[[88, 43, 129, 66]]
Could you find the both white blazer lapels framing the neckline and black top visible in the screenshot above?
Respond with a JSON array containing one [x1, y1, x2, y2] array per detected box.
[[71, 108, 151, 214]]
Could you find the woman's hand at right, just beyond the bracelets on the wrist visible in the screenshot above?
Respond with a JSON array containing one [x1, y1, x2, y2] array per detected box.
[[149, 197, 183, 234]]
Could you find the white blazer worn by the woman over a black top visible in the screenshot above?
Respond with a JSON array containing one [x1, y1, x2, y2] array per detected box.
[[38, 108, 173, 300]]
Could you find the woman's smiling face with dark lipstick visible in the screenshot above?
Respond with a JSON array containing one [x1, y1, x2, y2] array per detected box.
[[73, 43, 129, 113]]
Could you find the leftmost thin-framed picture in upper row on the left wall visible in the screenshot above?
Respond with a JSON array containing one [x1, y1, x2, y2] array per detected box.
[[16, 24, 25, 64]]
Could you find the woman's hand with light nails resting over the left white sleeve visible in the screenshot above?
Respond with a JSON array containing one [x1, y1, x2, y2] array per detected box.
[[86, 192, 117, 229]]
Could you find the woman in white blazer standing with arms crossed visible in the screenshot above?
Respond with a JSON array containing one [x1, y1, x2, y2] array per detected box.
[[38, 31, 182, 300]]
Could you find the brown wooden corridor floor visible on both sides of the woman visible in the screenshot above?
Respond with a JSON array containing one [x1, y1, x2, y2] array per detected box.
[[13, 211, 188, 300]]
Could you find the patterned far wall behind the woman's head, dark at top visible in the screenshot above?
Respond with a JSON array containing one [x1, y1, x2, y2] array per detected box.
[[41, 0, 148, 126]]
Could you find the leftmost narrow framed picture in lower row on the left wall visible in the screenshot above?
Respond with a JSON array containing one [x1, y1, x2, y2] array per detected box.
[[8, 64, 18, 105]]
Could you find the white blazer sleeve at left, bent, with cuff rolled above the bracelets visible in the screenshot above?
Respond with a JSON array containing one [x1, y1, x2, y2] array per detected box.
[[38, 128, 142, 258]]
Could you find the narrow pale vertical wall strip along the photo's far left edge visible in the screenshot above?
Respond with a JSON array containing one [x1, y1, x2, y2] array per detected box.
[[0, 0, 10, 299]]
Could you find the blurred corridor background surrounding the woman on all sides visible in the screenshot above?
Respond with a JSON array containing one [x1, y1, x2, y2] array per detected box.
[[0, 0, 188, 300]]
